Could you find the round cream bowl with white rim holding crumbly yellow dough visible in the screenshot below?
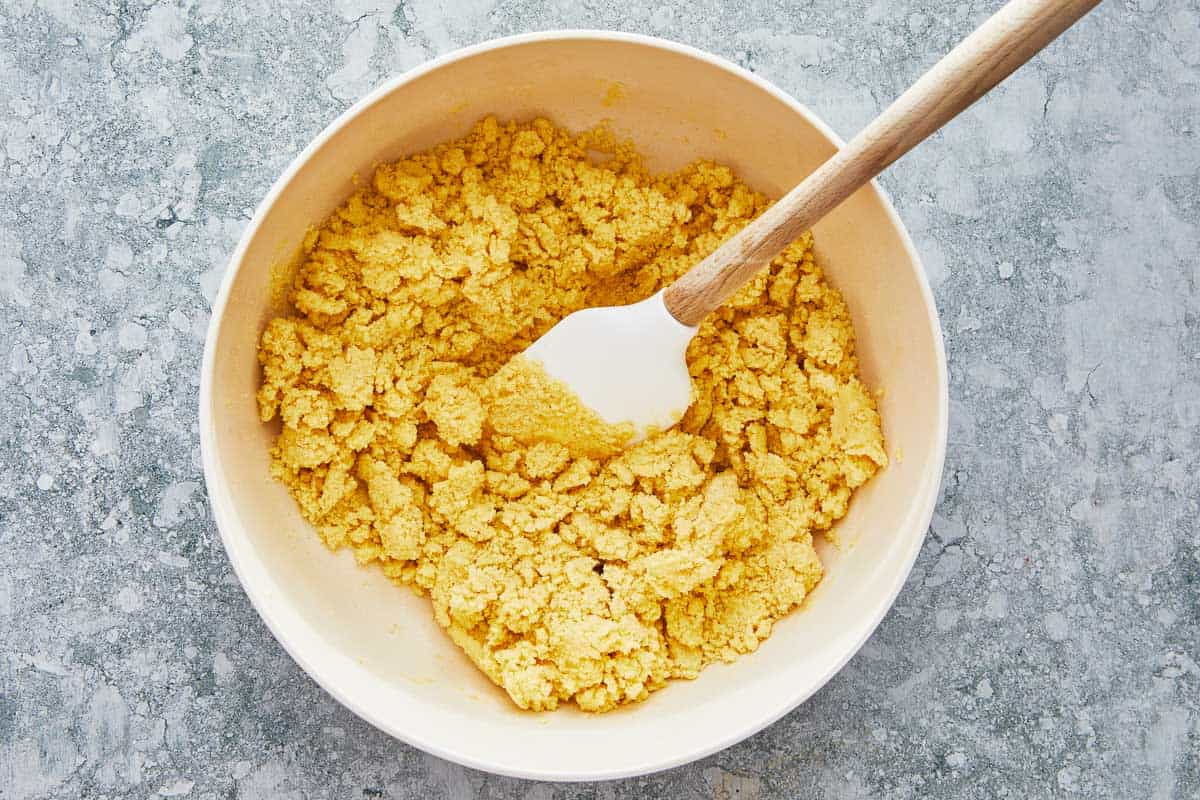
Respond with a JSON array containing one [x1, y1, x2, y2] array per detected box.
[[200, 31, 947, 781]]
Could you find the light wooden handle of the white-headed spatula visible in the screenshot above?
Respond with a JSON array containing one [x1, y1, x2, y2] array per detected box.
[[662, 0, 1100, 325]]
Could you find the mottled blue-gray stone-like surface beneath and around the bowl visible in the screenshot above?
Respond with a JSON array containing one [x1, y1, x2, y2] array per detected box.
[[0, 0, 1200, 800]]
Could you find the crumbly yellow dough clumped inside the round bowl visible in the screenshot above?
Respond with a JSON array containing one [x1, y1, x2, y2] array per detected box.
[[258, 118, 887, 711]]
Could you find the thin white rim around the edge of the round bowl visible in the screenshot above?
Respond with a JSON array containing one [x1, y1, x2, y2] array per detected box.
[[199, 29, 949, 781]]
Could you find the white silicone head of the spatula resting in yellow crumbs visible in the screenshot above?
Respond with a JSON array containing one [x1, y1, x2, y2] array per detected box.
[[524, 291, 697, 439]]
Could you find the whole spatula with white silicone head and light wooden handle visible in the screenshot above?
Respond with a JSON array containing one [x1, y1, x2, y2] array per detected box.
[[524, 0, 1099, 435]]
